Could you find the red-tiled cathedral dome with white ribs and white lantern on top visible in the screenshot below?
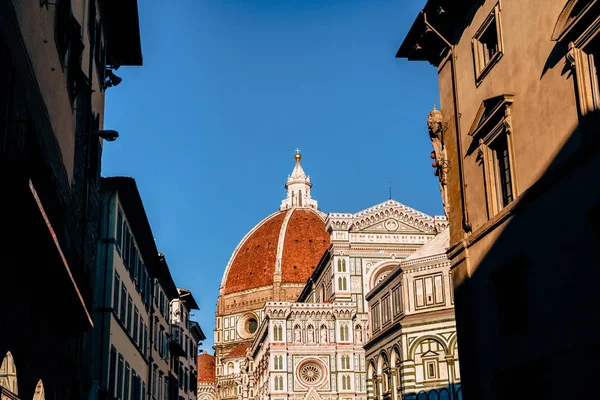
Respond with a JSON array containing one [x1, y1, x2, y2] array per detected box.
[[221, 154, 330, 298]]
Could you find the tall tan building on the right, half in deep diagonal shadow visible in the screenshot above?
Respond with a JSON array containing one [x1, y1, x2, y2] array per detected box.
[[397, 0, 600, 400]]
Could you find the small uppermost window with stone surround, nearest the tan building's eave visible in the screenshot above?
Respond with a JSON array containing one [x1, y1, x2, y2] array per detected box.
[[473, 5, 503, 84]]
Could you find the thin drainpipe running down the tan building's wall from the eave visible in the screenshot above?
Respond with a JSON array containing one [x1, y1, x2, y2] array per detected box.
[[421, 11, 473, 233]]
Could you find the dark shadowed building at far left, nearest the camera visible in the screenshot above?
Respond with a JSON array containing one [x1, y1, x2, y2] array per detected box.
[[0, 0, 142, 399]]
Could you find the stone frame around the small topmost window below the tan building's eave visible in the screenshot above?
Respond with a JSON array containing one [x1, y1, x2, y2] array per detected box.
[[471, 2, 504, 86]]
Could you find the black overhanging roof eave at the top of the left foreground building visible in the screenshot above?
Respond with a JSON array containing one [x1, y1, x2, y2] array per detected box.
[[100, 0, 142, 66]]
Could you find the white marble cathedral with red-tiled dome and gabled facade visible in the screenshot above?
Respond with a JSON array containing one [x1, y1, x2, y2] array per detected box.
[[209, 154, 446, 399]]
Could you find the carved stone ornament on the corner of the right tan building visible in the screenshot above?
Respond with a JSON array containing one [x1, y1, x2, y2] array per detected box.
[[427, 106, 450, 217]]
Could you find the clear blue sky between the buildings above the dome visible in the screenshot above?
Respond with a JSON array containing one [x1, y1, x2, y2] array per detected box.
[[102, 0, 443, 352]]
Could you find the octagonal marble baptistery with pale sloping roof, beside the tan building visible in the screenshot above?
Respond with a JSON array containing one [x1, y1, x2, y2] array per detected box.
[[365, 229, 462, 400]]
